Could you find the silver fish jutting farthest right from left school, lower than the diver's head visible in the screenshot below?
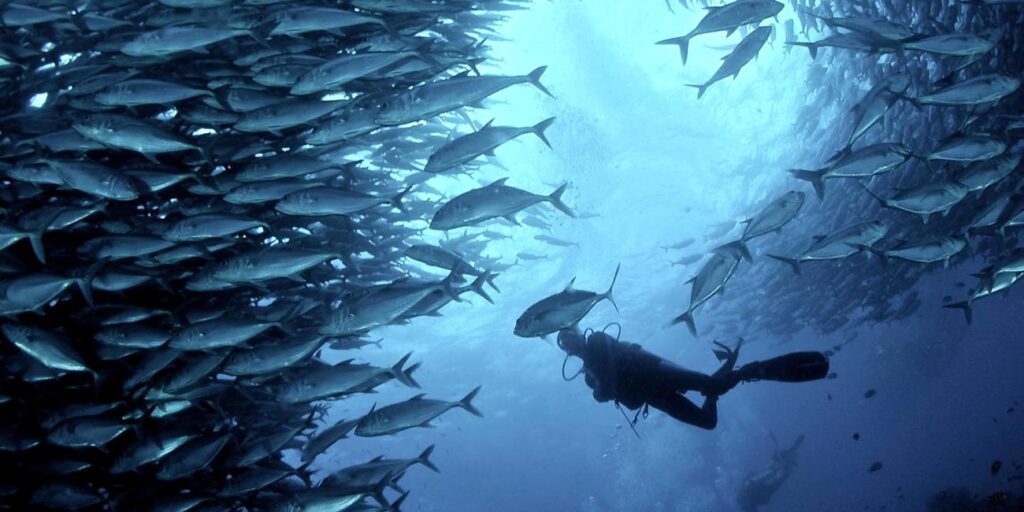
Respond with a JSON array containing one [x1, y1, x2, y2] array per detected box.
[[355, 386, 483, 437]]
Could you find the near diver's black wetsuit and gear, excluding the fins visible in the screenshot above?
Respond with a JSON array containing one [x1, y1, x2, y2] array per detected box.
[[558, 330, 738, 430]]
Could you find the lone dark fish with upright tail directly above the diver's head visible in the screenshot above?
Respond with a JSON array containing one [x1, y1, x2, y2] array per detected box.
[[513, 265, 621, 338]]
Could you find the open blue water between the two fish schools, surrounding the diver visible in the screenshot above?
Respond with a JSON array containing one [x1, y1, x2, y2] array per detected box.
[[318, 1, 1024, 512]]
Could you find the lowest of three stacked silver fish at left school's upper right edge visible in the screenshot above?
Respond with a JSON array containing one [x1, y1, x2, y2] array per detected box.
[[430, 178, 575, 230]]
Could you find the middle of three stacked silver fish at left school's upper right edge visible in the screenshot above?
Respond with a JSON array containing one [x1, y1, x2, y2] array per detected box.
[[423, 118, 555, 173]]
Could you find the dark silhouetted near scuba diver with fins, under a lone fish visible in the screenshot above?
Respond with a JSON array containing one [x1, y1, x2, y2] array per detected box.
[[558, 329, 828, 430]]
